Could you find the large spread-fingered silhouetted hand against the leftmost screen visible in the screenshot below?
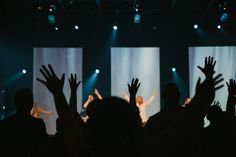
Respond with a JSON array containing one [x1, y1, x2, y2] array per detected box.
[[37, 64, 65, 93]]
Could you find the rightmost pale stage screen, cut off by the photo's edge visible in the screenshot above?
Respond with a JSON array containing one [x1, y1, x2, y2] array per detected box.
[[189, 46, 236, 110]]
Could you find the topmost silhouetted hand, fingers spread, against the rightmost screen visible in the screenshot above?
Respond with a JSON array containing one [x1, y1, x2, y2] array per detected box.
[[197, 56, 216, 78]]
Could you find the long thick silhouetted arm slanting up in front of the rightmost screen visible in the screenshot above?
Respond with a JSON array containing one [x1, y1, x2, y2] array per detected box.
[[141, 57, 223, 157]]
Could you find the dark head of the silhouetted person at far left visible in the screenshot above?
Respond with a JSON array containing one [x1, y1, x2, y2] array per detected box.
[[14, 88, 33, 114]]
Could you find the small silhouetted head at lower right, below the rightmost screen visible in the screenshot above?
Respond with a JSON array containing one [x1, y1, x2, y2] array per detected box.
[[206, 105, 224, 123]]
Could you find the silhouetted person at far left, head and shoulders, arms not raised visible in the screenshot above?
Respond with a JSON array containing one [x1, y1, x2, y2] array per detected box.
[[1, 88, 47, 157]]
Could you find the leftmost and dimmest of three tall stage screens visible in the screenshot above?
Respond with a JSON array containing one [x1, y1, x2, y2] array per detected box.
[[33, 48, 82, 134]]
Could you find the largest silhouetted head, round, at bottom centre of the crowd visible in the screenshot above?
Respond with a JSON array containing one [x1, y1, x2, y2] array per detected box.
[[87, 97, 139, 149]]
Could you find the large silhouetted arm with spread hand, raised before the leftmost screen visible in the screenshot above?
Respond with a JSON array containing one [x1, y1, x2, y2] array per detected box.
[[37, 65, 86, 157]]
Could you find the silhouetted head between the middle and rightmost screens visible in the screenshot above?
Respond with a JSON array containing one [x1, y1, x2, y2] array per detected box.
[[162, 82, 180, 105]]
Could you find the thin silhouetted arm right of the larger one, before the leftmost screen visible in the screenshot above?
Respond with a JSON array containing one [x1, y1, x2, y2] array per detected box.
[[68, 74, 80, 113]]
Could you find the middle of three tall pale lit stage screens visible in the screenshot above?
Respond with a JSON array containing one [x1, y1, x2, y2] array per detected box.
[[111, 47, 160, 117]]
